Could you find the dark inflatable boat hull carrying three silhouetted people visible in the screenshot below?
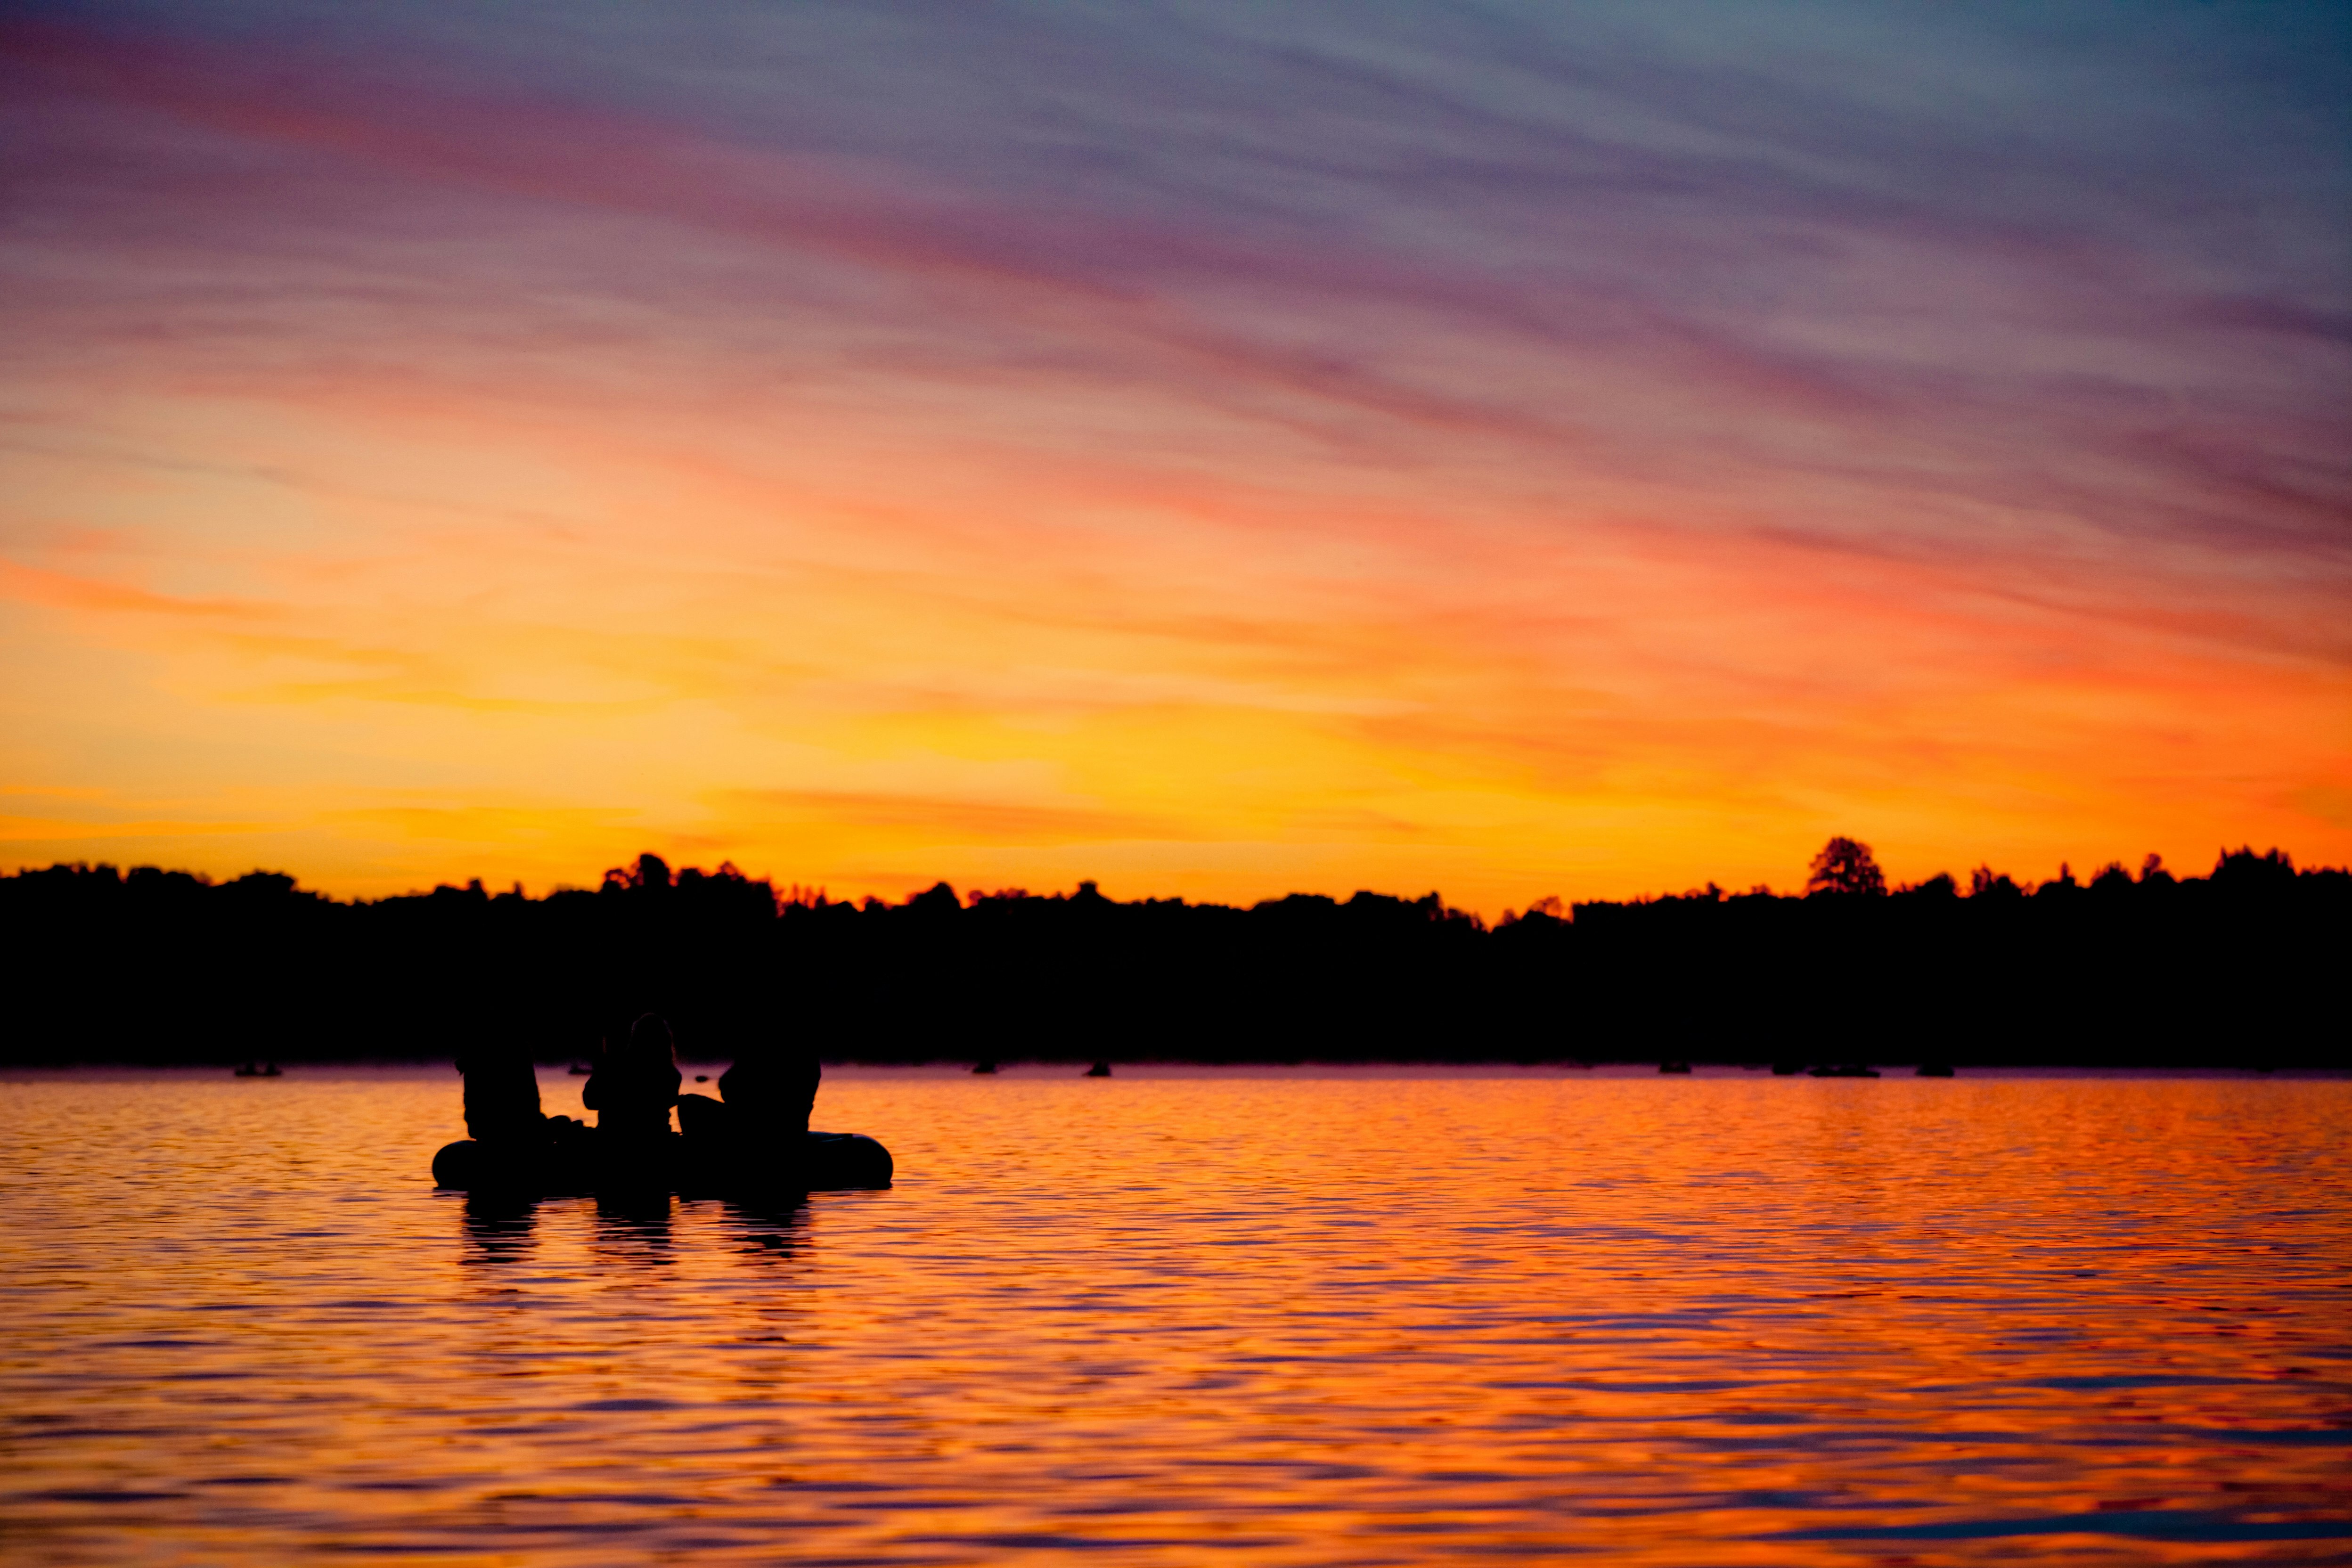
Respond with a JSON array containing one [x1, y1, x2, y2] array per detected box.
[[433, 1128, 894, 1197]]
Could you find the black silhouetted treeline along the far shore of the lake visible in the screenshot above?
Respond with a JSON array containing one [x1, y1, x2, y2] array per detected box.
[[0, 839, 2352, 1067]]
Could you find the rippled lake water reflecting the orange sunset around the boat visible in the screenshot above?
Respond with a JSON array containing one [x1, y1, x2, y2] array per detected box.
[[0, 1070, 2352, 1566]]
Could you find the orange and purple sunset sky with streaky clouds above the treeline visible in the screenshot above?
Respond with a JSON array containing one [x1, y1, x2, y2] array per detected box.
[[0, 0, 2352, 915]]
